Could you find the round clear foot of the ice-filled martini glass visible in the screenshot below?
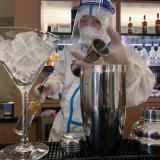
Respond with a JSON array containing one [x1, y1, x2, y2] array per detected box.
[[0, 143, 49, 160]]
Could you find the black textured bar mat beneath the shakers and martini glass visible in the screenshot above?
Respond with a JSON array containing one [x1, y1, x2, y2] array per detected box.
[[0, 140, 160, 160]]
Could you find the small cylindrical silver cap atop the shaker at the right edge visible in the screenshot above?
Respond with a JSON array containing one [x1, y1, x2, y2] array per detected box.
[[142, 107, 160, 121]]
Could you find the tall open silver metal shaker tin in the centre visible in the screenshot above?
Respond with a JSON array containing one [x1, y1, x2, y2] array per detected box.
[[80, 63, 126, 151]]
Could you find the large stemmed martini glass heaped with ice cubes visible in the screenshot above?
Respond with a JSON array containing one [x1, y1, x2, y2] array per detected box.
[[0, 27, 58, 160]]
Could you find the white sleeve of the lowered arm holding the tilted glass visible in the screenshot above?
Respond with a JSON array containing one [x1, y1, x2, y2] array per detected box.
[[47, 51, 65, 99]]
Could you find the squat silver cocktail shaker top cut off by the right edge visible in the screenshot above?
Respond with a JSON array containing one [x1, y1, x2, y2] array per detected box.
[[130, 107, 160, 154]]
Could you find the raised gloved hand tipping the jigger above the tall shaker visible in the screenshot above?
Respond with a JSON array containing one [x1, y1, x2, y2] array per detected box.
[[104, 27, 130, 67]]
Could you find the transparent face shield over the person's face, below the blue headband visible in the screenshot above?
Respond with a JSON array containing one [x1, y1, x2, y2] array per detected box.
[[71, 3, 114, 44]]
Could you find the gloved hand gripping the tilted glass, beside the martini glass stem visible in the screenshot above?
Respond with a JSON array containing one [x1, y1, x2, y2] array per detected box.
[[34, 82, 53, 102]]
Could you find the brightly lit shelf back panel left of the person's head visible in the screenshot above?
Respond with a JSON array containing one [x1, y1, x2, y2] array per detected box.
[[41, 1, 78, 31]]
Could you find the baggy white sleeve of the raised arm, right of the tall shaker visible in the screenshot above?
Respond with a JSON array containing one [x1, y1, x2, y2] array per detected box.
[[125, 46, 155, 107]]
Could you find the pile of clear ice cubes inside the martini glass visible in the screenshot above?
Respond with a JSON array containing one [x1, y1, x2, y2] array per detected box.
[[0, 32, 52, 83]]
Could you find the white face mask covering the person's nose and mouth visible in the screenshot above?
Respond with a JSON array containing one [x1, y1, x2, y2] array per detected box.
[[80, 26, 110, 44]]
